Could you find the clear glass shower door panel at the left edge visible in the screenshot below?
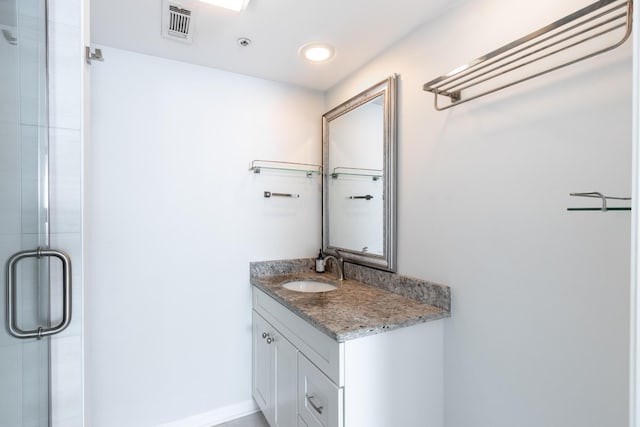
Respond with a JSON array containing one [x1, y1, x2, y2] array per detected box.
[[0, 0, 49, 427]]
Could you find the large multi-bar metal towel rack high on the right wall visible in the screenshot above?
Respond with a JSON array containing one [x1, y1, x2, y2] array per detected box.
[[423, 0, 633, 111]]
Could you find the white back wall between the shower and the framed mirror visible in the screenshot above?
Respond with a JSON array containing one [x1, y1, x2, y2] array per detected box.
[[85, 46, 325, 427]]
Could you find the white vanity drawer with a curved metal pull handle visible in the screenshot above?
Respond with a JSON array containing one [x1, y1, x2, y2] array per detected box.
[[298, 353, 344, 427]]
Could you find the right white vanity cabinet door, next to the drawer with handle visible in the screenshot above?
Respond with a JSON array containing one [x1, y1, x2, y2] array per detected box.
[[271, 332, 298, 427]]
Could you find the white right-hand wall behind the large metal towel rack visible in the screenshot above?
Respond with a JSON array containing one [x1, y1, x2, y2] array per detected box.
[[327, 0, 631, 427]]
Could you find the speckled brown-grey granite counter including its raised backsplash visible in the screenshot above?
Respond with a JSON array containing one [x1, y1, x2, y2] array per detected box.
[[250, 259, 451, 341]]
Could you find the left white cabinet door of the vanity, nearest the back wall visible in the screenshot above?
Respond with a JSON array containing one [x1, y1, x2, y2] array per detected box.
[[253, 311, 273, 418]]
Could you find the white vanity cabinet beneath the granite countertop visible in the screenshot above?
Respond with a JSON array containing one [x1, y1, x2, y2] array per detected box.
[[253, 286, 443, 427]]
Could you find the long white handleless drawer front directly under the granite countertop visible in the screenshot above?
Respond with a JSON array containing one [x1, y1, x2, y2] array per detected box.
[[253, 286, 344, 386]]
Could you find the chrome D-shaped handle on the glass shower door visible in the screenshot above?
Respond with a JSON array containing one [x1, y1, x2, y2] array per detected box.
[[7, 248, 71, 339]]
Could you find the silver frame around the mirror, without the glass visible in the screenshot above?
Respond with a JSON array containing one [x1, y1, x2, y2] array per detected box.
[[322, 74, 398, 271]]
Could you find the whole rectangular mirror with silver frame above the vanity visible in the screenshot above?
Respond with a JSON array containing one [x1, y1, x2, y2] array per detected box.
[[322, 75, 397, 271]]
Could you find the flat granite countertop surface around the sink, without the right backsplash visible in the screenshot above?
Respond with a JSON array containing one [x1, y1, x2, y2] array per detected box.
[[251, 263, 450, 342]]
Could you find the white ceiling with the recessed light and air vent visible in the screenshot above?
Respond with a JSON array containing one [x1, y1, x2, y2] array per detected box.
[[91, 0, 460, 90]]
